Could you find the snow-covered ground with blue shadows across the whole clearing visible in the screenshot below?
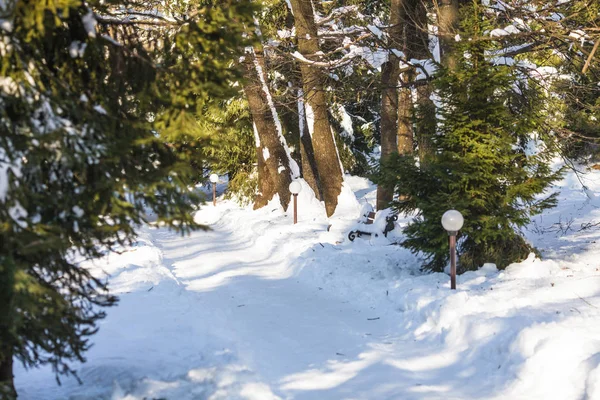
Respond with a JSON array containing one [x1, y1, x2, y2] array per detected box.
[[16, 167, 600, 400]]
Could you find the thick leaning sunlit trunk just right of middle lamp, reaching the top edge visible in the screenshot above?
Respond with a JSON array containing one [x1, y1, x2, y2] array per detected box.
[[290, 0, 343, 216]]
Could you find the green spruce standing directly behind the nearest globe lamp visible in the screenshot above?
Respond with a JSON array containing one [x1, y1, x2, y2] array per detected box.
[[382, 3, 559, 271]]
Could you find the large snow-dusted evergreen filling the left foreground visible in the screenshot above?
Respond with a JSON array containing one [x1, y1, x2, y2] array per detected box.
[[0, 0, 253, 398]]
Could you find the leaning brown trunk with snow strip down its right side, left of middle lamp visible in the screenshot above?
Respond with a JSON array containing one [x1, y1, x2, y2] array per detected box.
[[244, 48, 299, 209]]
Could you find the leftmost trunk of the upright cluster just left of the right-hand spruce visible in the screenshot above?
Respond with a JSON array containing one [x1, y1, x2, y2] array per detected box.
[[377, 0, 406, 210]]
